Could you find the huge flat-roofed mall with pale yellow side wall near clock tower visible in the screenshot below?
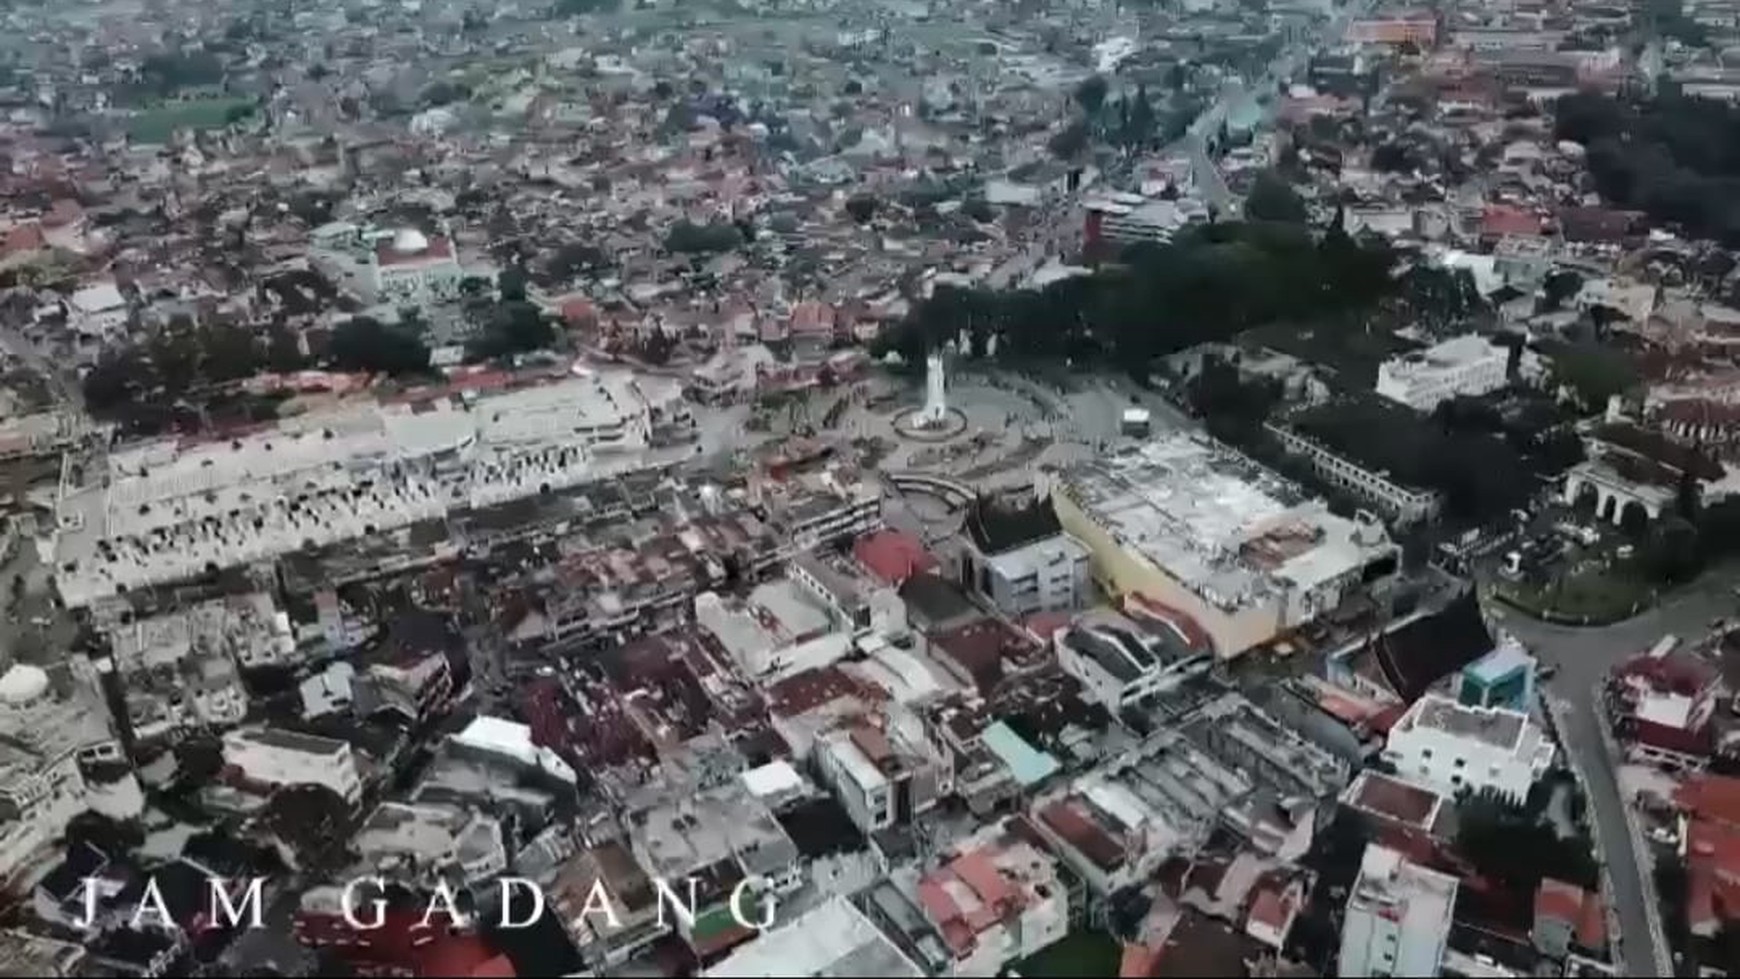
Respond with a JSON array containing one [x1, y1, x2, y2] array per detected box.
[[1051, 431, 1399, 657]]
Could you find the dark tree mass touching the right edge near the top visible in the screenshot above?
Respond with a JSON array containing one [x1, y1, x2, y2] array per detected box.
[[1556, 89, 1740, 247]]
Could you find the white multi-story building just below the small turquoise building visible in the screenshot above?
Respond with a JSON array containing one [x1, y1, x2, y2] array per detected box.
[[1383, 694, 1556, 802]]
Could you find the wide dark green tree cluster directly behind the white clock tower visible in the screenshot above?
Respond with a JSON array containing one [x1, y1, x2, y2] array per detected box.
[[875, 223, 1395, 376]]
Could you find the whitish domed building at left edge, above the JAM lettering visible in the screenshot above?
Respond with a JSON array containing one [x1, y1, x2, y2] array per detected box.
[[0, 664, 144, 880]]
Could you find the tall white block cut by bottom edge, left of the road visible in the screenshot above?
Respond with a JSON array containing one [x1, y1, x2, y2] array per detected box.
[[1340, 843, 1456, 977]]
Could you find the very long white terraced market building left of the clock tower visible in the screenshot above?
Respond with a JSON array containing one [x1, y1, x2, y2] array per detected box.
[[45, 372, 693, 607]]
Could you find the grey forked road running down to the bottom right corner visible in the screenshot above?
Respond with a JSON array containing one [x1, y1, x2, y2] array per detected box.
[[1495, 569, 1735, 976]]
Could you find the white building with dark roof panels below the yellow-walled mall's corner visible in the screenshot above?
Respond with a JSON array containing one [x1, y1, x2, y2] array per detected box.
[[1051, 614, 1215, 711]]
